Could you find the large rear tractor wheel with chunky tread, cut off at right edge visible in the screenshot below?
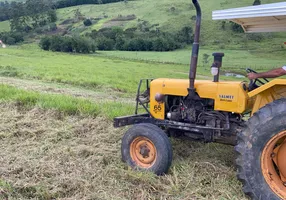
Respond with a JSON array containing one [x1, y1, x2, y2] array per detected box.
[[235, 98, 286, 200]]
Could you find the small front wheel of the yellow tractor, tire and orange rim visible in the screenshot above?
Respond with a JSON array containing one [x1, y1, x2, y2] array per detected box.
[[121, 124, 173, 175]]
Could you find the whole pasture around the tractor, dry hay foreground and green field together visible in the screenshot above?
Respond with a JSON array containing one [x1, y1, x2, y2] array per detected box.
[[0, 41, 281, 200]]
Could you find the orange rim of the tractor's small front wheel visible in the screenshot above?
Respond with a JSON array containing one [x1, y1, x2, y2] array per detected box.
[[130, 137, 157, 168]]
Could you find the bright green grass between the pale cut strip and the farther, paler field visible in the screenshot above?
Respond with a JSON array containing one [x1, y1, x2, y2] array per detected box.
[[0, 45, 191, 93]]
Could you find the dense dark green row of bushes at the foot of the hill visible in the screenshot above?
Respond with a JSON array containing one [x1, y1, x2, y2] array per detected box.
[[40, 26, 193, 53]]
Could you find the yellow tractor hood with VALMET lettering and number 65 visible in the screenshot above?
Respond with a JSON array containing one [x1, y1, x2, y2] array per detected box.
[[150, 79, 254, 119]]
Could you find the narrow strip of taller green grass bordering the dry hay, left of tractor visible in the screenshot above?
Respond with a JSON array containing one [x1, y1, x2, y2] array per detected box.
[[0, 84, 134, 120]]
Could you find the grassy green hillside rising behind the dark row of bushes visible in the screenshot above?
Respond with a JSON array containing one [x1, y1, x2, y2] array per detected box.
[[54, 0, 286, 48]]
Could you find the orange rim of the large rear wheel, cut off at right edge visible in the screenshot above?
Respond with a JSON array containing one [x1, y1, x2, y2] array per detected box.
[[261, 131, 286, 199]]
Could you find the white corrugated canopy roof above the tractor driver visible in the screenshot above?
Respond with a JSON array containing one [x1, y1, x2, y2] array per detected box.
[[213, 2, 286, 33]]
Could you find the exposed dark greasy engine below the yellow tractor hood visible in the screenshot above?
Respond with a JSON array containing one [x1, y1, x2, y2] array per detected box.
[[165, 96, 240, 144]]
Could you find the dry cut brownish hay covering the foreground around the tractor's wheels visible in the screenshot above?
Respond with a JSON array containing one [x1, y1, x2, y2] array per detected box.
[[0, 103, 246, 200]]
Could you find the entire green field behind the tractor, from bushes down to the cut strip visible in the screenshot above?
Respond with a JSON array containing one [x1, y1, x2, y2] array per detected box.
[[0, 45, 283, 91]]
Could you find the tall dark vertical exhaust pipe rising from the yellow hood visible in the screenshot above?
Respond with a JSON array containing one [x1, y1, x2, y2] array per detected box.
[[188, 0, 202, 98]]
